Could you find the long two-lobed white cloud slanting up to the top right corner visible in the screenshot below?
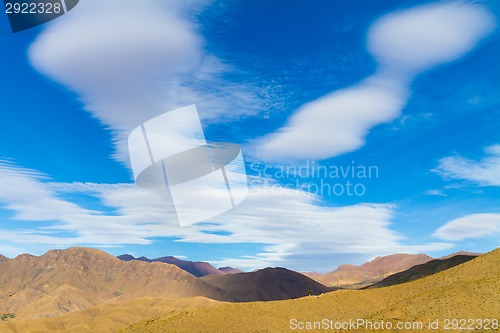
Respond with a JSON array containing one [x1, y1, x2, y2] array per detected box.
[[254, 2, 495, 160]]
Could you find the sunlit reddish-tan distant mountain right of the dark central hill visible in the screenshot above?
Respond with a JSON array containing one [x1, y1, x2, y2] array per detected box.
[[309, 254, 433, 287]]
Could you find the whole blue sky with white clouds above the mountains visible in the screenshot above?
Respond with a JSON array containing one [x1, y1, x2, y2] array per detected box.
[[0, 0, 500, 271]]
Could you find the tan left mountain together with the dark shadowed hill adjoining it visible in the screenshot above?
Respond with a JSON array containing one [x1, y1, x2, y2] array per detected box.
[[0, 248, 330, 319]]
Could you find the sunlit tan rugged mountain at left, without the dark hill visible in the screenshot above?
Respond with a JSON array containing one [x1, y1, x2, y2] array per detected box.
[[0, 248, 232, 318]]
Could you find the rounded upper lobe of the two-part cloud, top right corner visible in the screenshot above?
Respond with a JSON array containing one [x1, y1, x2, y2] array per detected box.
[[367, 1, 495, 72]]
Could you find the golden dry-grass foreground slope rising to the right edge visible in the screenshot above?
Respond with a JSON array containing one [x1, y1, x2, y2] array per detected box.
[[121, 249, 500, 333]]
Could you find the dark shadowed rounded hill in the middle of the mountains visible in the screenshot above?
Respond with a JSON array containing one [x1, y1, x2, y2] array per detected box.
[[202, 268, 332, 302]]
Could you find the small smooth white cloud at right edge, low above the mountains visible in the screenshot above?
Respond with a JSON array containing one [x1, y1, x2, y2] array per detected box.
[[434, 214, 500, 241]]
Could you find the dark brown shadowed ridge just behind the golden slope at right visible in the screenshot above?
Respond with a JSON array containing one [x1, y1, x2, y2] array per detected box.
[[364, 255, 477, 289]]
